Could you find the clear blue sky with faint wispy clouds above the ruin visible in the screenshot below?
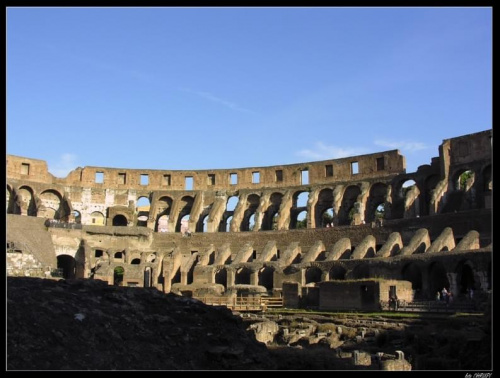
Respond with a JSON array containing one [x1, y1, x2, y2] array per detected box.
[[6, 7, 492, 177]]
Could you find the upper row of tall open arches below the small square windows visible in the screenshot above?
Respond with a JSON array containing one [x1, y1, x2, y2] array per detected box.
[[7, 159, 492, 232]]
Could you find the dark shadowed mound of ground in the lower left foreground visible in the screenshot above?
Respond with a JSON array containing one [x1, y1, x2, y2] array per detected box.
[[7, 277, 276, 370]]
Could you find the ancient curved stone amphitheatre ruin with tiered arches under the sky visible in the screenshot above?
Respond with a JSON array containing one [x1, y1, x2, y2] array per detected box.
[[7, 129, 492, 308]]
